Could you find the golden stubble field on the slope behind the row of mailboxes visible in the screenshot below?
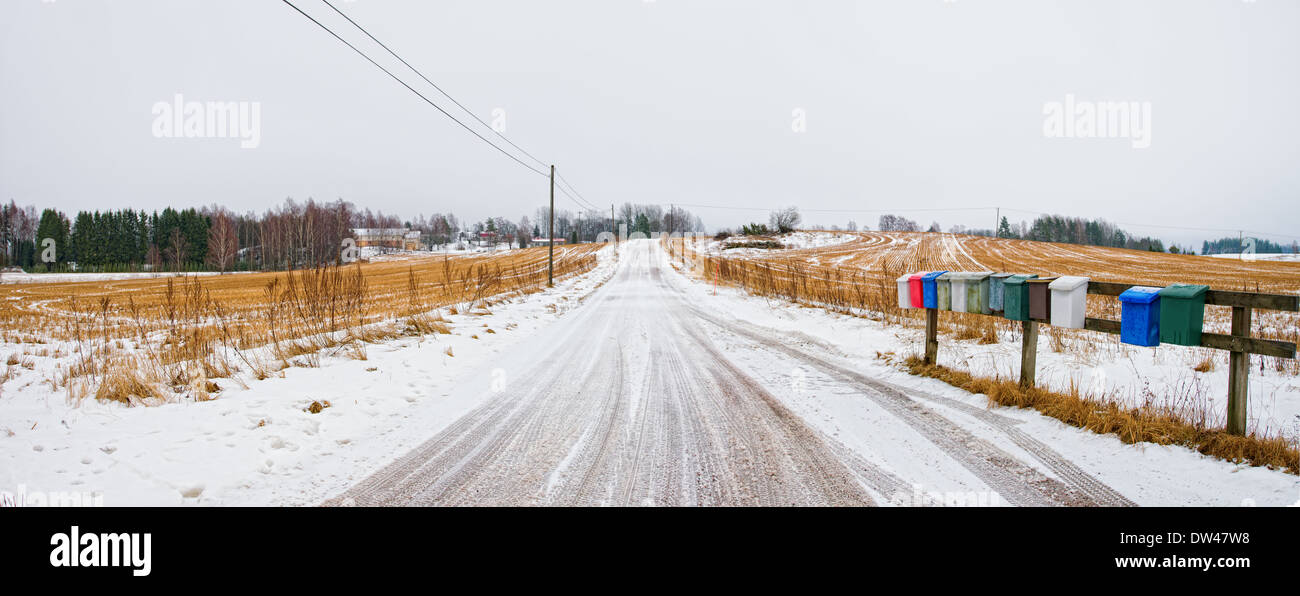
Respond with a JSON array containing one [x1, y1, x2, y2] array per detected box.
[[668, 232, 1300, 375]]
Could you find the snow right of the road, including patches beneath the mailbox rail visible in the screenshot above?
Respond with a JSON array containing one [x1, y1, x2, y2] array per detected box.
[[660, 248, 1300, 506]]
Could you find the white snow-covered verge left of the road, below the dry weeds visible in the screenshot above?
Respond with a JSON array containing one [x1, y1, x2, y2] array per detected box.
[[0, 247, 616, 506]]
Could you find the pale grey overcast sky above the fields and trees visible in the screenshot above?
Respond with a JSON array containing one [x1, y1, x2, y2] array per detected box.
[[0, 0, 1300, 249]]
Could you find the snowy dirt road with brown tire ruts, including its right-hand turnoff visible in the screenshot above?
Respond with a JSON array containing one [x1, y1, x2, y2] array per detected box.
[[328, 241, 1131, 505]]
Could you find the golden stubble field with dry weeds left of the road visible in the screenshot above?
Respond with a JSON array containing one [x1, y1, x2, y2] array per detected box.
[[0, 245, 603, 403]]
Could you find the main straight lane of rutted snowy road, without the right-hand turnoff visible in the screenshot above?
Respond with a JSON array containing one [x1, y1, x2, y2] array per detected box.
[[328, 243, 883, 505]]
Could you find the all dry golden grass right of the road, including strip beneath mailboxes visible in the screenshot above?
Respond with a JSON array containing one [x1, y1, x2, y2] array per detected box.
[[666, 232, 1300, 472]]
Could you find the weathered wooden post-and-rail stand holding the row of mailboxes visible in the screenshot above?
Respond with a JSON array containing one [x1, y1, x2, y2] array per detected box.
[[926, 281, 1300, 435]]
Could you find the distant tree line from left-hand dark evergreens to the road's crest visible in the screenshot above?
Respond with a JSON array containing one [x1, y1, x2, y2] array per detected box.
[[0, 199, 702, 272]]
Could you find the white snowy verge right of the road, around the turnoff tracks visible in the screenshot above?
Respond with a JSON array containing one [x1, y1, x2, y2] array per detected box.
[[666, 248, 1300, 506]]
